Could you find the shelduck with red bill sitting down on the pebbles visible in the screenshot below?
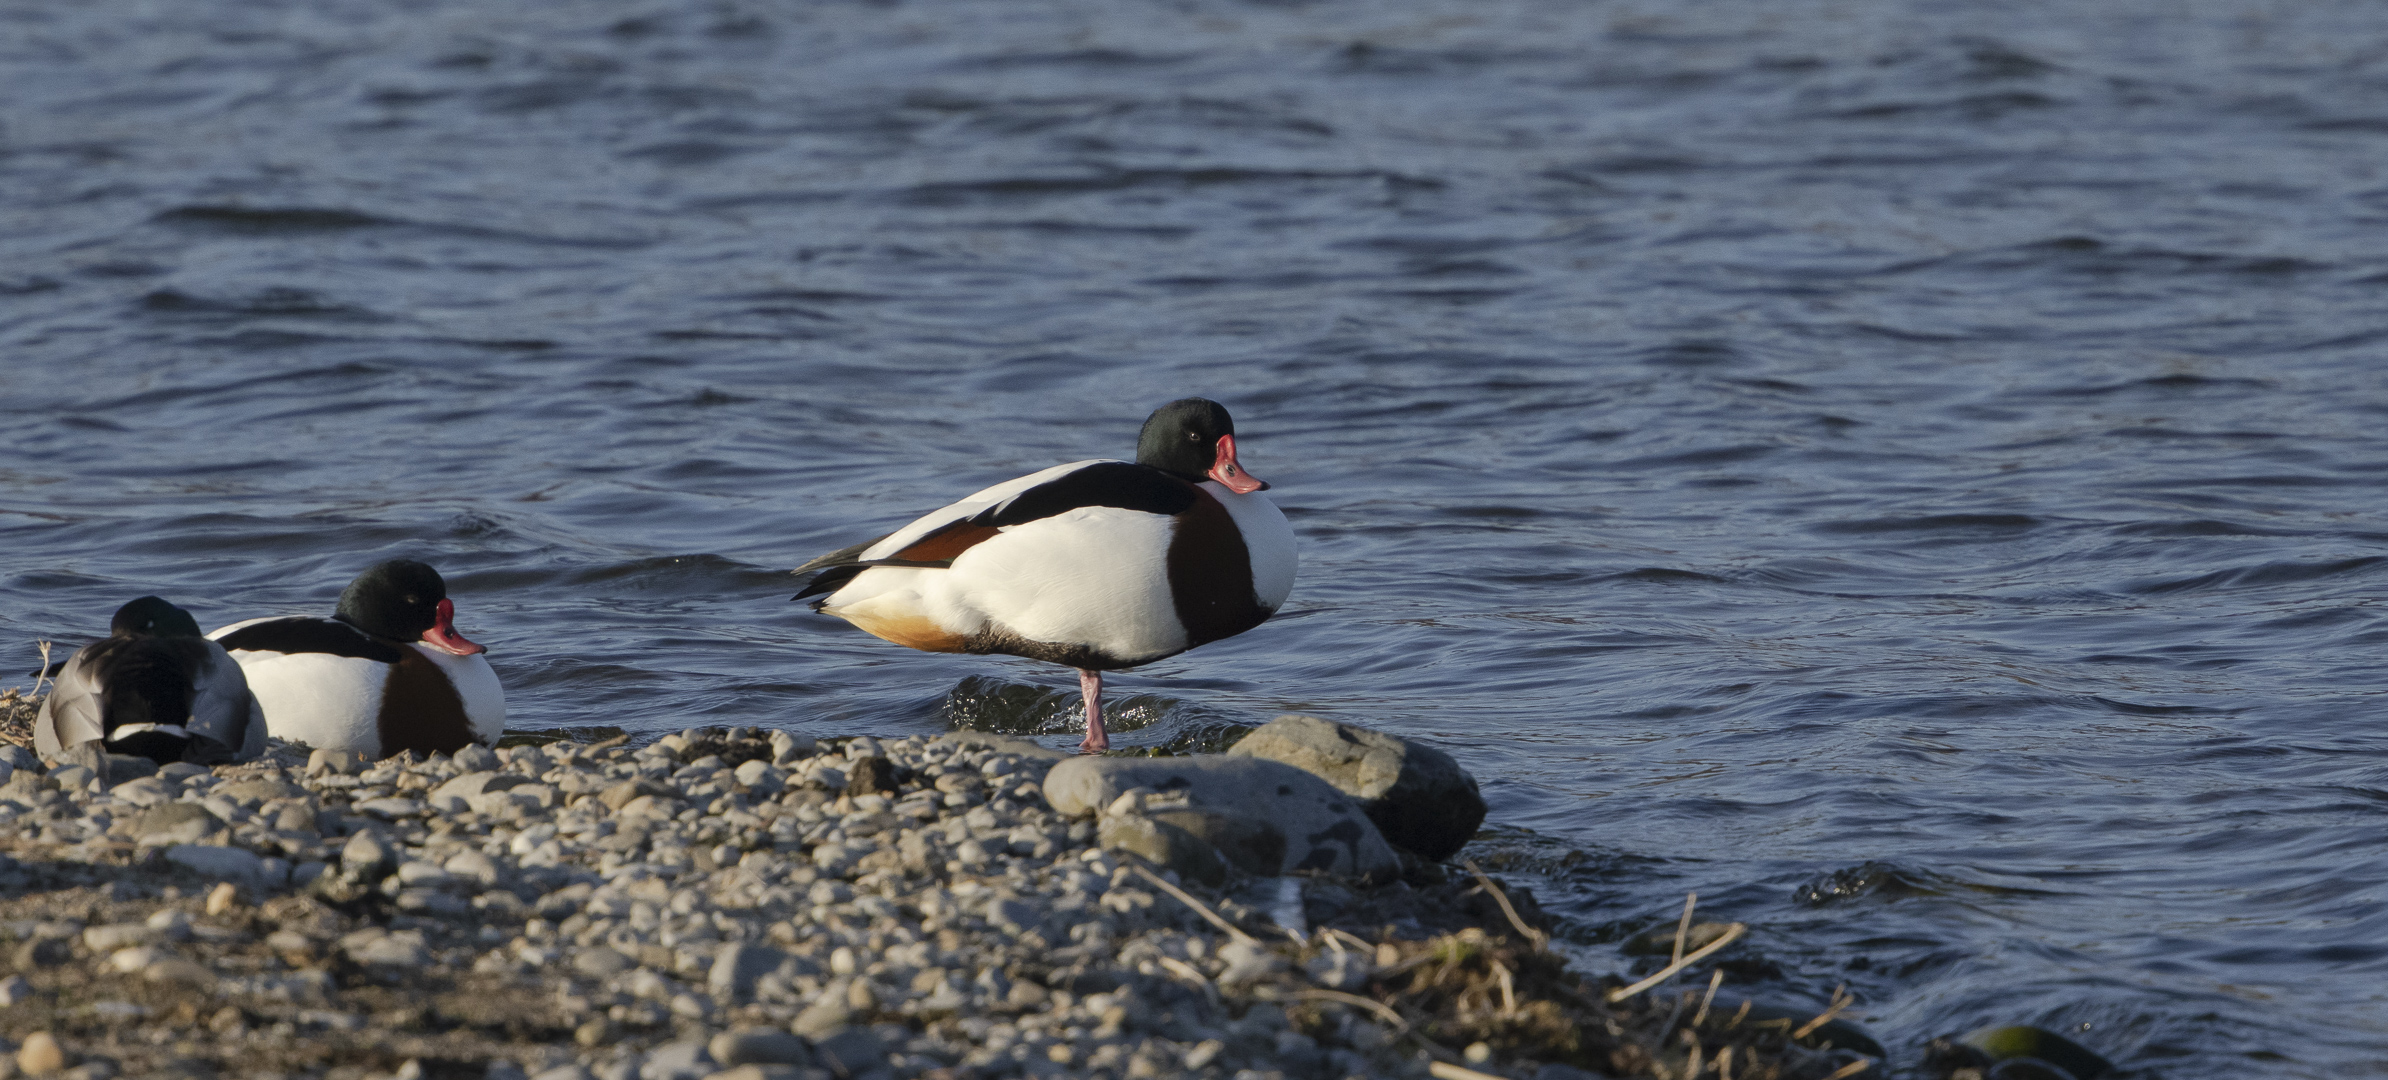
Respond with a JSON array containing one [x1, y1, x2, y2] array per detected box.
[[210, 559, 506, 757]]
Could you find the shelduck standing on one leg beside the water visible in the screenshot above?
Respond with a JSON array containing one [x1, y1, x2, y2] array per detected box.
[[795, 397, 1294, 753]]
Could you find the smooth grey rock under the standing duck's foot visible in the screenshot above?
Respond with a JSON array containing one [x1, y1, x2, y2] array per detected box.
[[1044, 755, 1402, 882]]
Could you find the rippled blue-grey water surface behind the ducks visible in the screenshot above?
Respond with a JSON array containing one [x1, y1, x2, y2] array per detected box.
[[0, 0, 2388, 1078]]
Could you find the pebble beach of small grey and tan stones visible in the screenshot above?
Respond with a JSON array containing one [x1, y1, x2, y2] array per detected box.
[[0, 688, 1879, 1080]]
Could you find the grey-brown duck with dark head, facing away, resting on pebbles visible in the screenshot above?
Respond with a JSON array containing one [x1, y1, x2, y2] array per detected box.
[[33, 597, 265, 765]]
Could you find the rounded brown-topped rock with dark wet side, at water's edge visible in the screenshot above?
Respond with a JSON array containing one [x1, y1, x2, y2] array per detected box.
[[1227, 714, 1485, 860]]
